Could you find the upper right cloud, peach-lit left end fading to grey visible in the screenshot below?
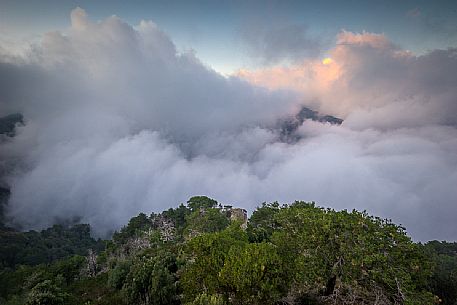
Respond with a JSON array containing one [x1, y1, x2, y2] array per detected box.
[[238, 31, 457, 129]]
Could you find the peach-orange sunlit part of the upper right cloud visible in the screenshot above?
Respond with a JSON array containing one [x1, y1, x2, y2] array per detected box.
[[237, 31, 414, 118]]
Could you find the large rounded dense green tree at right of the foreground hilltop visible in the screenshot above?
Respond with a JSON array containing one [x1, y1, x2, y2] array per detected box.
[[272, 202, 433, 304]]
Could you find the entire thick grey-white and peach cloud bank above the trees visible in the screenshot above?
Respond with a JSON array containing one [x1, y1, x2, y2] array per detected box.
[[0, 9, 457, 240]]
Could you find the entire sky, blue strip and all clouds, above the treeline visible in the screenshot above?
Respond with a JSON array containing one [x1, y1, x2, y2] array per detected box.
[[0, 1, 457, 241]]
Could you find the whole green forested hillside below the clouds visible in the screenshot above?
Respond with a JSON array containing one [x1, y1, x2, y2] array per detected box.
[[0, 196, 457, 305]]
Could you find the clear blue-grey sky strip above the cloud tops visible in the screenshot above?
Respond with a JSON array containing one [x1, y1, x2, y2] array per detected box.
[[0, 0, 457, 74]]
